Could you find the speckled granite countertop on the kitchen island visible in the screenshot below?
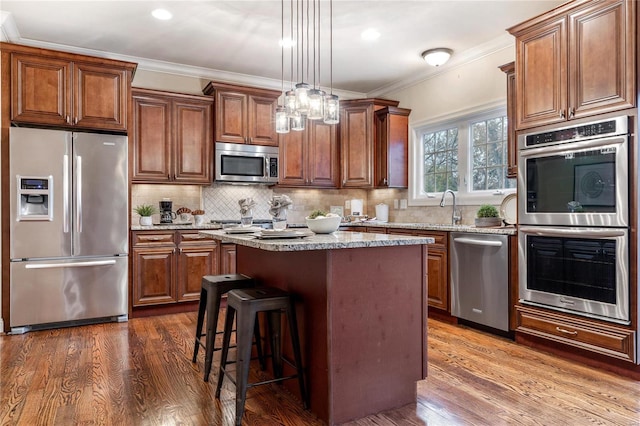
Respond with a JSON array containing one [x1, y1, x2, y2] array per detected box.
[[200, 230, 435, 251]]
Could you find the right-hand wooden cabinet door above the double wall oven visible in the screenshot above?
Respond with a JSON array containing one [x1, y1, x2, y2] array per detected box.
[[569, 0, 636, 118]]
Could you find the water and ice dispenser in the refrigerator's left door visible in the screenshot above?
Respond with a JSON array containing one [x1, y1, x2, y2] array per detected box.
[[16, 175, 53, 221]]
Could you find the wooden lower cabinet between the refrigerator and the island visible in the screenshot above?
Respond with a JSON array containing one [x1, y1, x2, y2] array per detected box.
[[131, 231, 220, 307]]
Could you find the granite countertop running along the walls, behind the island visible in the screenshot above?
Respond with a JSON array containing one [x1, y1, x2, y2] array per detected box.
[[131, 221, 517, 235]]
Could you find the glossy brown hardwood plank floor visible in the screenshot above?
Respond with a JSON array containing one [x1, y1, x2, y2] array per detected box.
[[0, 312, 640, 426]]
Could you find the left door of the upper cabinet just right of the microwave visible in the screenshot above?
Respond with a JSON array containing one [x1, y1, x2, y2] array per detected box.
[[278, 130, 307, 186]]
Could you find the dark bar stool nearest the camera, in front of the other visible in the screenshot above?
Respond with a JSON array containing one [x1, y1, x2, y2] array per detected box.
[[216, 287, 309, 425]]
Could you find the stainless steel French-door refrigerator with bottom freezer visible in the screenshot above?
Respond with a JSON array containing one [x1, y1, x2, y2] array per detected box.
[[9, 127, 129, 333]]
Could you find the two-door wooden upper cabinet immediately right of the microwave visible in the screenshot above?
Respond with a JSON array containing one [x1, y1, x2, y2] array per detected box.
[[278, 120, 339, 188]]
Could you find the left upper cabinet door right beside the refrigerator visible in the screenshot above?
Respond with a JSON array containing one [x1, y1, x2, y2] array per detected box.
[[132, 95, 172, 183]]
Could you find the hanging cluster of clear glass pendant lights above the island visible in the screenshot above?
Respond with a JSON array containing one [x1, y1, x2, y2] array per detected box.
[[276, 0, 339, 133]]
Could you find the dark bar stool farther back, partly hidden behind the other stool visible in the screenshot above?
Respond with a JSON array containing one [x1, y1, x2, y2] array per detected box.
[[192, 274, 265, 382]]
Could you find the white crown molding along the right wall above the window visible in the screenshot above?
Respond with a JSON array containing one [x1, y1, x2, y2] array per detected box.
[[367, 32, 515, 98]]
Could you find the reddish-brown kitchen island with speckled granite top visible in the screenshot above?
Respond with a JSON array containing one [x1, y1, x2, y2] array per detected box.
[[200, 230, 433, 425]]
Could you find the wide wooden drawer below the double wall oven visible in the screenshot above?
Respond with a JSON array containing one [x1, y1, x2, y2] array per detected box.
[[516, 306, 636, 362]]
